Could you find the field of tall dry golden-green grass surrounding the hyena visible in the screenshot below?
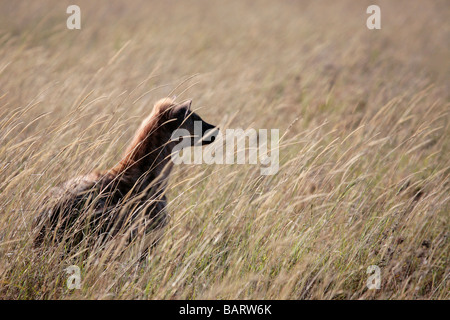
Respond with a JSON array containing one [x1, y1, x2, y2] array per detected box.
[[0, 0, 450, 299]]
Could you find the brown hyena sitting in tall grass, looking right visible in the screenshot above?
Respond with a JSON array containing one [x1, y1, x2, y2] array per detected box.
[[34, 98, 218, 247]]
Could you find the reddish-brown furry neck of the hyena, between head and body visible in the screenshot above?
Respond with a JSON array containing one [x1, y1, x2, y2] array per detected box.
[[110, 116, 173, 192]]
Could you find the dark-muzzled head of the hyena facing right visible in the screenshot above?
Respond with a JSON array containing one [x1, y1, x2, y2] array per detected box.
[[161, 100, 219, 147]]
